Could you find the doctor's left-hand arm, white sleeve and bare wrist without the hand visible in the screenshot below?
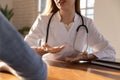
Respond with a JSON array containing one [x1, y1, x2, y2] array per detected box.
[[24, 15, 47, 56]]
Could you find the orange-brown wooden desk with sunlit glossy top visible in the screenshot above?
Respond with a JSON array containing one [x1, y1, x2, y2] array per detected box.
[[0, 60, 120, 80]]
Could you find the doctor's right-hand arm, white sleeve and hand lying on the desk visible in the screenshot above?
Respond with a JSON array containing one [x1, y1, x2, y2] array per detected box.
[[66, 20, 115, 62]]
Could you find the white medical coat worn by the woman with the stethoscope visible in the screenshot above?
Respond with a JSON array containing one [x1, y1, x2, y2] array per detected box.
[[25, 12, 115, 60]]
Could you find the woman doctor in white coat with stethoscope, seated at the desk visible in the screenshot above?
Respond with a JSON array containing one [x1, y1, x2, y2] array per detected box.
[[25, 0, 115, 62]]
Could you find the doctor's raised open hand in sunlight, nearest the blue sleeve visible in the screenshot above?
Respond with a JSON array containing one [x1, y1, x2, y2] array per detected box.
[[41, 43, 64, 53]]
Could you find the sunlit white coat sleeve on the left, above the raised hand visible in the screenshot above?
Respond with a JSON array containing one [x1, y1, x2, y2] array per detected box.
[[24, 16, 43, 47]]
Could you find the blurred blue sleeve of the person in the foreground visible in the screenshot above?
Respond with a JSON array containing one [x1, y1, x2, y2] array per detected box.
[[0, 12, 47, 80]]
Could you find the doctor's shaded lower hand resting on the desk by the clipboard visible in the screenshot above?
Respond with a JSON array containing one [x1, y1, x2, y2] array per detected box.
[[65, 51, 97, 62]]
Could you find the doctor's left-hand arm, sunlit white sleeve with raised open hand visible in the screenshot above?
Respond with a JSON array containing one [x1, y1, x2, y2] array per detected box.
[[24, 15, 64, 56]]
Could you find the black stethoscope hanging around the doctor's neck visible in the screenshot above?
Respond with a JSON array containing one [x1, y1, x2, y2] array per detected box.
[[45, 12, 88, 50]]
